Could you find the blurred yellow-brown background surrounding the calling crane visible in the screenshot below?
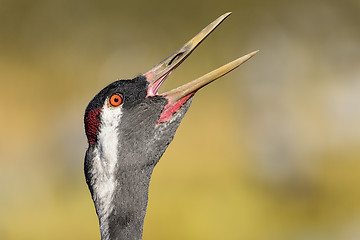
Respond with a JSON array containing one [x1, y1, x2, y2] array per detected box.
[[0, 0, 360, 240]]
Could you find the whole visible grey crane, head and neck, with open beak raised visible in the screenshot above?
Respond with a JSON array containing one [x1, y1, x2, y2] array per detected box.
[[84, 13, 256, 239]]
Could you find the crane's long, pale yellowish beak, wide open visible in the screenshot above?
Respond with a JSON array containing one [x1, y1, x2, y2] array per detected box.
[[144, 12, 258, 105]]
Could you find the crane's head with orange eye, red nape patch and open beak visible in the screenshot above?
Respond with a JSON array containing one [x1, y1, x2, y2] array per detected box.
[[85, 13, 257, 172]]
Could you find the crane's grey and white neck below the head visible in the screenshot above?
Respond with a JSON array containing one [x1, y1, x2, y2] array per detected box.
[[85, 148, 155, 240]]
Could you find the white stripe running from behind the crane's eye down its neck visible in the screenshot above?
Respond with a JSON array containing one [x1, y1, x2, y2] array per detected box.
[[92, 100, 122, 239]]
